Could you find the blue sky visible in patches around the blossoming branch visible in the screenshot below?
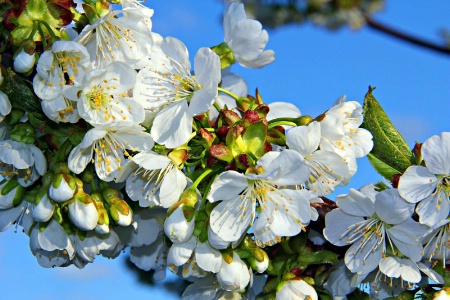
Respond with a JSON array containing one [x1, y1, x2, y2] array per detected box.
[[0, 0, 450, 300]]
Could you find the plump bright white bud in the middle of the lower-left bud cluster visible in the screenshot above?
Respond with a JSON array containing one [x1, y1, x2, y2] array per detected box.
[[69, 192, 98, 231]]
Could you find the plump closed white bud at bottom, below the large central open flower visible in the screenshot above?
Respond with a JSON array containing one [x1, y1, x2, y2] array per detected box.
[[217, 252, 250, 292]]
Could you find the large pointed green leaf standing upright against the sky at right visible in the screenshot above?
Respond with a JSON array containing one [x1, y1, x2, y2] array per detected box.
[[361, 87, 414, 180]]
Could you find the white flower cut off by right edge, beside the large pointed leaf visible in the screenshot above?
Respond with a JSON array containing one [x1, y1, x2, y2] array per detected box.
[[398, 132, 450, 226]]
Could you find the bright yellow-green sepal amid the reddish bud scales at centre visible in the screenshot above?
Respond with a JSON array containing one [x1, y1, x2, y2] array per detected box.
[[242, 121, 267, 159]]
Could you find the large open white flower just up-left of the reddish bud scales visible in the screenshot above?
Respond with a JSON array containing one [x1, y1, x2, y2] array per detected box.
[[134, 37, 221, 148]]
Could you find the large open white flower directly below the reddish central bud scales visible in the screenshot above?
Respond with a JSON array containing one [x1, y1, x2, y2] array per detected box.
[[207, 150, 311, 245]]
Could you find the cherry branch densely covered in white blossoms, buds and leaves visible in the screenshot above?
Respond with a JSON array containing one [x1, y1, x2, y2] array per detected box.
[[0, 0, 450, 299]]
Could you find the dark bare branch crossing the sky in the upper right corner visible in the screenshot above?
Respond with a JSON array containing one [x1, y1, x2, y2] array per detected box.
[[365, 16, 450, 55]]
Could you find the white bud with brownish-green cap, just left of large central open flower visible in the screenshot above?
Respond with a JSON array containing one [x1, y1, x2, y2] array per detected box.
[[164, 204, 195, 244]]
